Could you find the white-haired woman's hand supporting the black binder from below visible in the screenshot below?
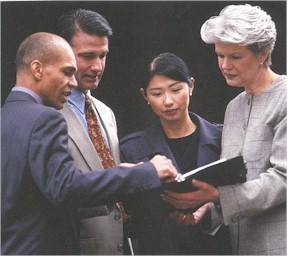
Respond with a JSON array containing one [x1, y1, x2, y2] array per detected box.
[[160, 179, 219, 210]]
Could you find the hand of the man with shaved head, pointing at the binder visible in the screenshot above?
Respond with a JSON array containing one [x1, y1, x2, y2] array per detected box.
[[150, 155, 178, 183]]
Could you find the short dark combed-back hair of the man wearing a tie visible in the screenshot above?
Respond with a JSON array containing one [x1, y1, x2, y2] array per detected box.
[[58, 9, 113, 43]]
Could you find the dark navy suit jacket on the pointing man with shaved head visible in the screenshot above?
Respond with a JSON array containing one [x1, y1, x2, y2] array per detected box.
[[1, 92, 161, 255]]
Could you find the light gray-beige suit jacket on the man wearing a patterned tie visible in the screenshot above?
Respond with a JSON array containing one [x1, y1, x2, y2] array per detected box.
[[59, 97, 123, 255]]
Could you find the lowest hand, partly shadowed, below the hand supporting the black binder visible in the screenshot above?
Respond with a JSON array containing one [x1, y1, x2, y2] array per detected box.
[[169, 203, 210, 226]]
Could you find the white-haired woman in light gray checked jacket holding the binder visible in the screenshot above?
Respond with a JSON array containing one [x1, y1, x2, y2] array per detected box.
[[162, 4, 287, 255]]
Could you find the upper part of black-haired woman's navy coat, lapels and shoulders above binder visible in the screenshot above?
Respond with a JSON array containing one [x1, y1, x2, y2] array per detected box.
[[120, 113, 222, 168]]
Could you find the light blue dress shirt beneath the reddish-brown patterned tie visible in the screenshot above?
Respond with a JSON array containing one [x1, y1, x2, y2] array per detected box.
[[68, 88, 110, 148]]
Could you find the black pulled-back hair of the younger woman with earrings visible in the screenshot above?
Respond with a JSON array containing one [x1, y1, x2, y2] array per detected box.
[[142, 53, 191, 90]]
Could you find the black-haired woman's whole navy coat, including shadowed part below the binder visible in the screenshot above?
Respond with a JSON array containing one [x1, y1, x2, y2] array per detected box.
[[120, 113, 229, 255]]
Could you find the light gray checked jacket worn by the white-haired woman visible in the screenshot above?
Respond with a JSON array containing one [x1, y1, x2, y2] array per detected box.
[[212, 75, 287, 256]]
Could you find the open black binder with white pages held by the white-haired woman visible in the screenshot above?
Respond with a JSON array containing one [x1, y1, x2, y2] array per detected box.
[[163, 156, 247, 193]]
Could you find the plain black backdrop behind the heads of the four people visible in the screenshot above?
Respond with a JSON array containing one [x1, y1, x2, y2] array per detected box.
[[1, 1, 286, 138]]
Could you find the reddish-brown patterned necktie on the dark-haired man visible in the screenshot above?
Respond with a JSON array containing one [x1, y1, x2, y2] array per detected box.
[[85, 95, 128, 223]]
